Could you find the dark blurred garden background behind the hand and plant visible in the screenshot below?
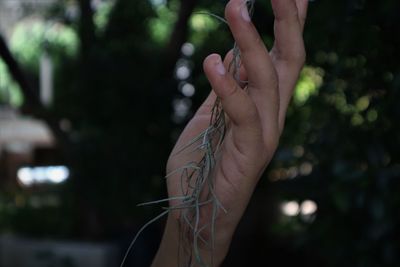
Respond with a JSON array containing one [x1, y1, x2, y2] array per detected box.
[[0, 0, 400, 267]]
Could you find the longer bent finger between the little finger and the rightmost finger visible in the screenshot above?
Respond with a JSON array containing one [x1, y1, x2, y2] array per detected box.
[[225, 0, 279, 140]]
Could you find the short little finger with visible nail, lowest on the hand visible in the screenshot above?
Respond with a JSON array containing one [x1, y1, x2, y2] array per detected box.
[[204, 54, 262, 151]]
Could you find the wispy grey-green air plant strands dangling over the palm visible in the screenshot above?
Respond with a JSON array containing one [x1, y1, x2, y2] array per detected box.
[[120, 0, 255, 267]]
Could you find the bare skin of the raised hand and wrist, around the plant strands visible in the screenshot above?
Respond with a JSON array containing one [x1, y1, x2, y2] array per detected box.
[[152, 0, 308, 267]]
